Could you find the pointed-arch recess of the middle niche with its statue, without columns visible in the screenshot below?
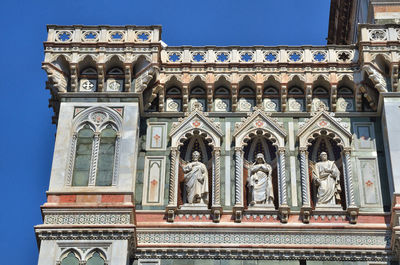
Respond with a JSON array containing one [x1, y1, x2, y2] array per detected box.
[[243, 131, 278, 209]]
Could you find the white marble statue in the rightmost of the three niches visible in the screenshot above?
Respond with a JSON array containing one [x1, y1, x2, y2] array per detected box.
[[312, 152, 341, 206]]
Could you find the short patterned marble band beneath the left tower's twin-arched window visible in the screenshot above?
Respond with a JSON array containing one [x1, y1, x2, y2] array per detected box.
[[43, 213, 131, 225]]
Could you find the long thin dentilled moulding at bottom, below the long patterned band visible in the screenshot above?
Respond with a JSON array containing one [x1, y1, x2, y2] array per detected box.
[[133, 247, 393, 262]]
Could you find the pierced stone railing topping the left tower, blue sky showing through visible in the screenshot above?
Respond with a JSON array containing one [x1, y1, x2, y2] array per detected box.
[[47, 25, 161, 43]]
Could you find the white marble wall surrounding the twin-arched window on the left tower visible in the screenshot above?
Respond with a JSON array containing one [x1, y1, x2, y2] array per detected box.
[[49, 102, 139, 192]]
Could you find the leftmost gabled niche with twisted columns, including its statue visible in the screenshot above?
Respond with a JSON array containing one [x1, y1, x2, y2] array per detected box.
[[166, 104, 223, 222]]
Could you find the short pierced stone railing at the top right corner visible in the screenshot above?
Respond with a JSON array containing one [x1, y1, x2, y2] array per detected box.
[[359, 24, 400, 42]]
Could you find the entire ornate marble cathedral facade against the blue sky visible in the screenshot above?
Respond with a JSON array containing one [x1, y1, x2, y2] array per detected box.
[[35, 0, 400, 265]]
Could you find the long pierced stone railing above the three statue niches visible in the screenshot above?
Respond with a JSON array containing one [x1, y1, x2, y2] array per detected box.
[[161, 46, 358, 64]]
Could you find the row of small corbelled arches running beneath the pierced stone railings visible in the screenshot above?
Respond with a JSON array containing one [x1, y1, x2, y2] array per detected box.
[[43, 51, 397, 115]]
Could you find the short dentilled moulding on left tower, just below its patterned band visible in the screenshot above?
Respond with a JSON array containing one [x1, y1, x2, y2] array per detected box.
[[35, 227, 135, 240]]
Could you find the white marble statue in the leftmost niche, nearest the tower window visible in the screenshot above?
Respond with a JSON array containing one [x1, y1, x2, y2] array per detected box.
[[183, 151, 208, 204]]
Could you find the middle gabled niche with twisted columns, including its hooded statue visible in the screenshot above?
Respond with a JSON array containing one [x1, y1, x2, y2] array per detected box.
[[233, 107, 289, 223]]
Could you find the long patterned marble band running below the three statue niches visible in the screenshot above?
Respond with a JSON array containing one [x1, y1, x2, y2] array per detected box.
[[137, 229, 391, 249]]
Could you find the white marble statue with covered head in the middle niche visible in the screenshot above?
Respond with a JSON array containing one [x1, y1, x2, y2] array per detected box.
[[247, 153, 274, 206]]
